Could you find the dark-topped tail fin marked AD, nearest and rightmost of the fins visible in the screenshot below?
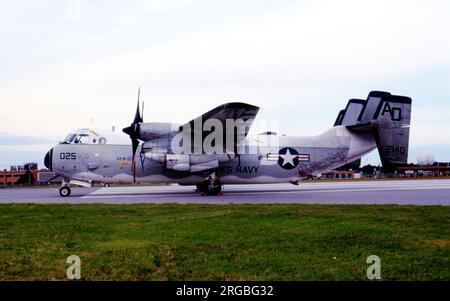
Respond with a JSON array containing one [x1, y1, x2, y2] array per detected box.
[[342, 91, 412, 169]]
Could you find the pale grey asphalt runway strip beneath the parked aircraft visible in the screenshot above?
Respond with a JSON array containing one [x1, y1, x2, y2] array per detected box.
[[0, 180, 450, 206]]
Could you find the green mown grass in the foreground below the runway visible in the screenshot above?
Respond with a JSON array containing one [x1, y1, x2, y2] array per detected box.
[[0, 204, 450, 280]]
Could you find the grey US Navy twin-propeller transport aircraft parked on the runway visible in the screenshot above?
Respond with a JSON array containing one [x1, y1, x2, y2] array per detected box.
[[45, 91, 411, 197]]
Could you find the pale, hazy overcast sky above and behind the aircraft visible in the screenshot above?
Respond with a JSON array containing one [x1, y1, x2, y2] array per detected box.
[[0, 0, 450, 169]]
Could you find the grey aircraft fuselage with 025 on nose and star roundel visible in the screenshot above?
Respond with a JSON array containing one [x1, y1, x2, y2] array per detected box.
[[46, 126, 376, 185]]
